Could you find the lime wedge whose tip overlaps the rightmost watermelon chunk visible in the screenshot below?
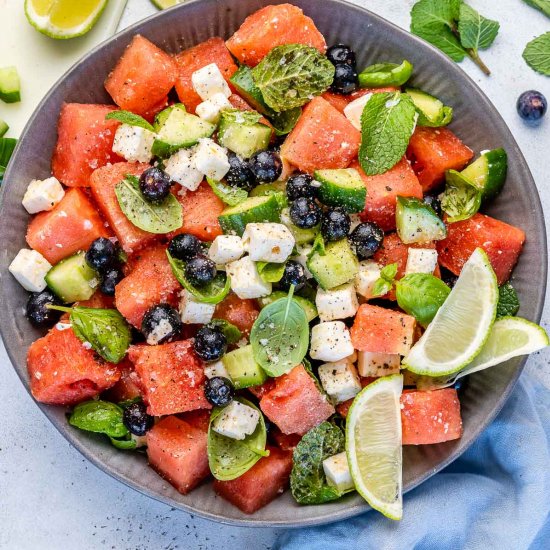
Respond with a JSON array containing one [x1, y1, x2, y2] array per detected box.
[[403, 248, 498, 376]]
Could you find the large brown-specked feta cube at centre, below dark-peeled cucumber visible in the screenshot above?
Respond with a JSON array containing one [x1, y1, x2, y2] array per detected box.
[[243, 223, 295, 264]]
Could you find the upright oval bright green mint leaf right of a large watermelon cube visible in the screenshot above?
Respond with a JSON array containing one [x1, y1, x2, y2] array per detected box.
[[359, 92, 417, 176]]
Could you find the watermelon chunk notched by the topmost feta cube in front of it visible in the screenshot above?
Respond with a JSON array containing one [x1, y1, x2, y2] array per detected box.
[[174, 36, 238, 113]]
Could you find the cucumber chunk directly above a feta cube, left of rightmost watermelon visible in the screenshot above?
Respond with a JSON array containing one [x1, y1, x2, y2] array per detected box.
[[395, 197, 447, 244]]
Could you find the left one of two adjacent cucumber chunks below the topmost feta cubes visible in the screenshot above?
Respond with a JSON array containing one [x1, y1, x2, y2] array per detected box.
[[153, 109, 216, 158]]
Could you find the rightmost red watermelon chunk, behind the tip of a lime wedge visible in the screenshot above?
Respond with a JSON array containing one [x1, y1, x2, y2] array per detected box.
[[437, 214, 525, 285]]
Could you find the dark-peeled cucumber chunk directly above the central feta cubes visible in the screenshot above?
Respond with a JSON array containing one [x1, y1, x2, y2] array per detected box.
[[218, 195, 281, 235]]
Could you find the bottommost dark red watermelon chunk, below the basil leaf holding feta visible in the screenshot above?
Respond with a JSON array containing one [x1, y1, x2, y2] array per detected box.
[[214, 447, 292, 514]]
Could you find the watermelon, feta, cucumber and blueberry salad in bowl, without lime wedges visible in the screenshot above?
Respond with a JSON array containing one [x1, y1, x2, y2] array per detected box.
[[6, 4, 548, 514]]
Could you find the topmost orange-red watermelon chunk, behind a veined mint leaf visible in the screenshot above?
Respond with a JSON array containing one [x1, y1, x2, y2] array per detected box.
[[226, 4, 327, 67]]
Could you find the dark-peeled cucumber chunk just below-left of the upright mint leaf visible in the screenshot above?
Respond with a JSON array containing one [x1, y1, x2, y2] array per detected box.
[[314, 168, 367, 213]]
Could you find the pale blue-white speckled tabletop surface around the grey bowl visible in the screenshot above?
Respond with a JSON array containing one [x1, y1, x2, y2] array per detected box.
[[0, 0, 550, 550]]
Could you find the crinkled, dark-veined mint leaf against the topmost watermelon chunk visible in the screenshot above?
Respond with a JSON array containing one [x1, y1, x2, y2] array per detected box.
[[252, 44, 334, 112]]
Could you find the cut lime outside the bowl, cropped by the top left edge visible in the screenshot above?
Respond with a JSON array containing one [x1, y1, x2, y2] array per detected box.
[[25, 0, 108, 39]]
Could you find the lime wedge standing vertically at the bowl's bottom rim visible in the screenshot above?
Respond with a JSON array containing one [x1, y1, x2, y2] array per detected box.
[[346, 374, 403, 519]]
